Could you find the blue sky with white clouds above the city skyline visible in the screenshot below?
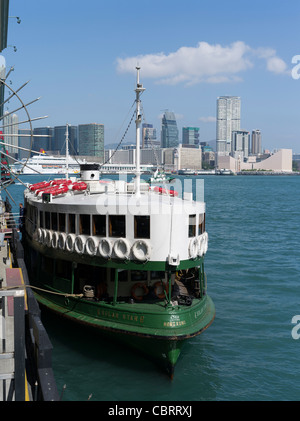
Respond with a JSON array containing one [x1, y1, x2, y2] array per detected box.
[[2, 0, 300, 153]]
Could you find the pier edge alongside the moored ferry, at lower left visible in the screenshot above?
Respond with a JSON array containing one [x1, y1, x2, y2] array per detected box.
[[0, 201, 60, 401]]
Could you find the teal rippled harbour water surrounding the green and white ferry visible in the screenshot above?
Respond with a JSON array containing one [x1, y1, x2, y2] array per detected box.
[[2, 176, 300, 403]]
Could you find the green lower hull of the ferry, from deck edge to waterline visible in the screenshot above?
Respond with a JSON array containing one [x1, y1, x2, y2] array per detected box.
[[31, 292, 215, 379]]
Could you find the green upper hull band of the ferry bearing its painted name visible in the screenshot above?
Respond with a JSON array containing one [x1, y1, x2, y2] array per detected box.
[[35, 293, 215, 340]]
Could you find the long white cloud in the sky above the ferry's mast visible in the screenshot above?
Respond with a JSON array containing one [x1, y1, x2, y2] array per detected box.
[[117, 41, 286, 85]]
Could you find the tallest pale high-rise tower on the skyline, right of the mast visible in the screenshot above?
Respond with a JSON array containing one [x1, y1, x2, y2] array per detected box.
[[216, 96, 241, 155]]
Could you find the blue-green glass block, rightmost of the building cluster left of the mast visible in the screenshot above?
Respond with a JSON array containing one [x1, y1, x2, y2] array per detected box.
[[78, 123, 104, 159]]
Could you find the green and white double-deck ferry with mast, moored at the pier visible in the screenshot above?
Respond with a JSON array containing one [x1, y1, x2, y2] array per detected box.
[[22, 68, 215, 377]]
